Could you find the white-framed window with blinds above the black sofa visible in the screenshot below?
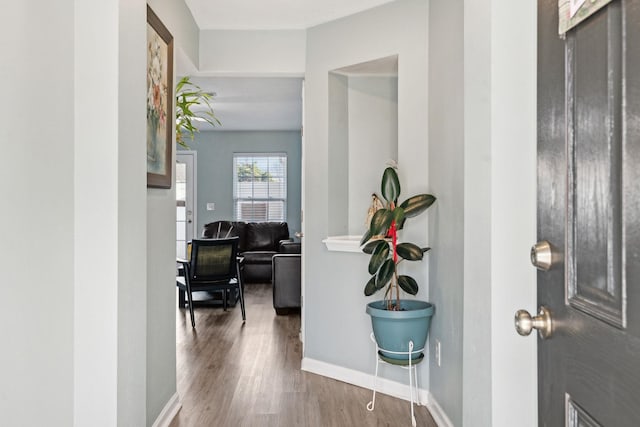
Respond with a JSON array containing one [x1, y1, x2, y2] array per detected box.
[[233, 153, 287, 222]]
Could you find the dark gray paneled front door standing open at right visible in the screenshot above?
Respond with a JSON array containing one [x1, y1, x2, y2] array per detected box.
[[538, 0, 640, 427]]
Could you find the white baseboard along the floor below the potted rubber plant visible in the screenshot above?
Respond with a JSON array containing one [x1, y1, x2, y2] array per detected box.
[[301, 357, 453, 427]]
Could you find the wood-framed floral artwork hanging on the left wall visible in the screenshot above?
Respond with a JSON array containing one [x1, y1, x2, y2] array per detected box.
[[147, 5, 174, 188]]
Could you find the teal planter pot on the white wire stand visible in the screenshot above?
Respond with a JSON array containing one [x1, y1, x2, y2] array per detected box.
[[367, 300, 433, 360]]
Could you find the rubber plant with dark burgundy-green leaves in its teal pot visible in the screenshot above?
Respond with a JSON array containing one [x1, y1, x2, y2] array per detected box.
[[360, 167, 436, 361]]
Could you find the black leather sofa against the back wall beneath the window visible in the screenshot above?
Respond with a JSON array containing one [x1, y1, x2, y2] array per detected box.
[[202, 221, 292, 283]]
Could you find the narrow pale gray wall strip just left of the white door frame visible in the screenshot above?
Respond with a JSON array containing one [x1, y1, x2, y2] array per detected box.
[[463, 1, 497, 425]]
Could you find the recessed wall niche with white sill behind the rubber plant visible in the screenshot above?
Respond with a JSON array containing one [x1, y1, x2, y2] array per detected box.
[[325, 55, 398, 252]]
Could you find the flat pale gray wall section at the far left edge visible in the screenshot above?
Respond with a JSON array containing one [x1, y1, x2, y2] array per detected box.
[[0, 0, 75, 426]]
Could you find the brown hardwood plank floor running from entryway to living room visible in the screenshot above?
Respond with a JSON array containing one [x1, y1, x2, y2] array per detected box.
[[170, 285, 436, 427]]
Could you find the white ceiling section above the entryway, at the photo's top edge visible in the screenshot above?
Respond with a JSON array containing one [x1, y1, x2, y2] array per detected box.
[[185, 0, 393, 30]]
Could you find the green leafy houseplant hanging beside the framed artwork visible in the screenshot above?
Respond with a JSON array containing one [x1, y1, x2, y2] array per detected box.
[[176, 76, 221, 148]]
